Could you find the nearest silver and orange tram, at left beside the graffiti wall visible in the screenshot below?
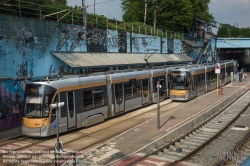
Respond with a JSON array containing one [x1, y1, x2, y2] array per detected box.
[[22, 66, 178, 137]]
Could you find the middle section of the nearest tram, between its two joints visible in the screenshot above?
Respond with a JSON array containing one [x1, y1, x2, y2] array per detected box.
[[110, 71, 150, 115]]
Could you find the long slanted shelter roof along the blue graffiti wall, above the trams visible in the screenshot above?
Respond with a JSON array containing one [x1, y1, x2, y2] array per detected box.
[[51, 52, 193, 68]]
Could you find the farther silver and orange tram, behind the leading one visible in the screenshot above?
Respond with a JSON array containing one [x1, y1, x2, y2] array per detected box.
[[170, 60, 238, 101]]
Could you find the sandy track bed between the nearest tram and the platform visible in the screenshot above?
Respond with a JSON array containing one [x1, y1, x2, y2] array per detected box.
[[0, 86, 234, 165]]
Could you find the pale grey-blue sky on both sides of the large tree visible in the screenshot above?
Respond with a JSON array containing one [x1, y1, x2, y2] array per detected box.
[[67, 0, 250, 32]]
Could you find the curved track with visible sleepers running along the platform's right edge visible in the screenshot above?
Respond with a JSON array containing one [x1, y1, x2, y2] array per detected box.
[[125, 87, 249, 166]]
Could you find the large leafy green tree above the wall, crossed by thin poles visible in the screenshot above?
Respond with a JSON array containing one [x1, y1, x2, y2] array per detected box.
[[121, 0, 214, 31]]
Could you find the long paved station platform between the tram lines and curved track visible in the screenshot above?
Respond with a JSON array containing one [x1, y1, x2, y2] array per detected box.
[[77, 76, 250, 166]]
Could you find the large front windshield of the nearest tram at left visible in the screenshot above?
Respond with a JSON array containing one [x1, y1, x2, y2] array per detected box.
[[24, 84, 52, 118]]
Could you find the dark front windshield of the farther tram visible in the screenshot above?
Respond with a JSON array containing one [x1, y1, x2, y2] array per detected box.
[[171, 71, 189, 90]]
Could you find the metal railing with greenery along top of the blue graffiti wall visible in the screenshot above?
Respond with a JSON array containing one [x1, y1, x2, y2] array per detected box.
[[0, 0, 187, 40]]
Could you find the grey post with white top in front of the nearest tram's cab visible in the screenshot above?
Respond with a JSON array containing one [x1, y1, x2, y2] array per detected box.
[[49, 102, 64, 166]]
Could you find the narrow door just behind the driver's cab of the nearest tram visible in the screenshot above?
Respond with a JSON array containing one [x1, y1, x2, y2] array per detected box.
[[67, 91, 76, 129]]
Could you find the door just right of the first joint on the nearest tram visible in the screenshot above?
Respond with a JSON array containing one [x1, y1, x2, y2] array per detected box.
[[114, 83, 124, 113]]
